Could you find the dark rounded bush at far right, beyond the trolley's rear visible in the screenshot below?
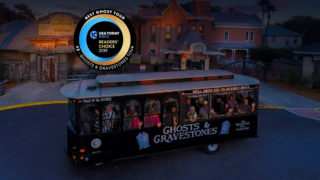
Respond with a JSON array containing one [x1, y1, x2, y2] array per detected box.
[[283, 69, 309, 89]]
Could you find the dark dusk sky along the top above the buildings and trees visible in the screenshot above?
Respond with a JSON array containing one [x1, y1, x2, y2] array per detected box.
[[3, 0, 320, 22]]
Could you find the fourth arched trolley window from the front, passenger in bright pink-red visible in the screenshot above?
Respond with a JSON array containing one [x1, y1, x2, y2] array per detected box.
[[144, 98, 161, 128]]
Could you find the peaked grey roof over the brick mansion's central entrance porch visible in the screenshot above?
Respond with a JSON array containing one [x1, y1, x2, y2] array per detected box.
[[169, 29, 206, 51]]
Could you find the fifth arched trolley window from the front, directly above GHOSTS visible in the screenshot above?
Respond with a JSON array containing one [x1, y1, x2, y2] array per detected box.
[[162, 97, 182, 126]]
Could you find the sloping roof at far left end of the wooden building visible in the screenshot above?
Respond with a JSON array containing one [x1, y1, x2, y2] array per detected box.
[[0, 20, 38, 50]]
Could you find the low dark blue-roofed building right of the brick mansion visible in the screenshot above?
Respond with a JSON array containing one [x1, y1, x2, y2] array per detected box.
[[262, 25, 303, 49]]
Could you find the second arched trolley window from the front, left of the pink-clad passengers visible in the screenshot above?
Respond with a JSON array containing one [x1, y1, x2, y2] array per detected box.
[[101, 102, 120, 133]]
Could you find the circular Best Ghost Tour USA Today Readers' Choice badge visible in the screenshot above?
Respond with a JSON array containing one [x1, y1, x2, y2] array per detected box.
[[74, 9, 136, 70]]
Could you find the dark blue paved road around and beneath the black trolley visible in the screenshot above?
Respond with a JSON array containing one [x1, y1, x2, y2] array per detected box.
[[0, 105, 320, 180]]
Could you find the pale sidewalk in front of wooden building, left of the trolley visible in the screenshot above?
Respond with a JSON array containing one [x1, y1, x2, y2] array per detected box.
[[0, 81, 67, 107]]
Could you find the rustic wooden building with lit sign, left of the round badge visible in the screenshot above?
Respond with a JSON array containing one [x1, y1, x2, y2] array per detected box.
[[0, 13, 87, 82]]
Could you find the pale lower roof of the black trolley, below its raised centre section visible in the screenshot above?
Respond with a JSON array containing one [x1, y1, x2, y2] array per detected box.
[[60, 70, 259, 99]]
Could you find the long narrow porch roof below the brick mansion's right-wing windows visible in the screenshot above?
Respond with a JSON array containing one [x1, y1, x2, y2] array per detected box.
[[211, 41, 257, 49]]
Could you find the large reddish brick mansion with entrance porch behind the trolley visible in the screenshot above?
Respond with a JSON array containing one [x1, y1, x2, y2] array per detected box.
[[139, 0, 262, 70]]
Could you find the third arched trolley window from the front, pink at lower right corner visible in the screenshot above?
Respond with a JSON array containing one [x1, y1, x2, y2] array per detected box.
[[123, 99, 143, 130]]
